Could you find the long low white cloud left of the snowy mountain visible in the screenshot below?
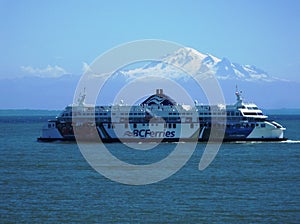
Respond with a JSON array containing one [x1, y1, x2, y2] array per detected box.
[[21, 65, 68, 78]]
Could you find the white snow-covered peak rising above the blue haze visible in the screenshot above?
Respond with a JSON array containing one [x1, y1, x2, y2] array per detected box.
[[122, 48, 276, 81]]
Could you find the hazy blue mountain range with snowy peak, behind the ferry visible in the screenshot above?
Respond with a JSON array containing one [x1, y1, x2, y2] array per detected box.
[[0, 48, 300, 110]]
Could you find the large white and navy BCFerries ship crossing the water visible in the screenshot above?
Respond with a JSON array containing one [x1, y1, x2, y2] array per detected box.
[[38, 89, 286, 142]]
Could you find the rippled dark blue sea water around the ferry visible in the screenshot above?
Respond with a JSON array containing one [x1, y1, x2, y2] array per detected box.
[[0, 111, 300, 223]]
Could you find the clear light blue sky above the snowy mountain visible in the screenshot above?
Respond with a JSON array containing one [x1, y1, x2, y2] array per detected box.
[[0, 0, 300, 82]]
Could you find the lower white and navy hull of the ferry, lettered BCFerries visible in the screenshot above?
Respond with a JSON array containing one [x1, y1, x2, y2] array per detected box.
[[38, 122, 286, 142]]
